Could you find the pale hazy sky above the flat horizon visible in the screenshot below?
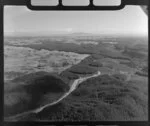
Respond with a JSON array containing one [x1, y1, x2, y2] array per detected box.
[[4, 2, 148, 35]]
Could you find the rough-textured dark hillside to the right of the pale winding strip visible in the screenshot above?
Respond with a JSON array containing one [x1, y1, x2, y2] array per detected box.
[[32, 75, 148, 121]]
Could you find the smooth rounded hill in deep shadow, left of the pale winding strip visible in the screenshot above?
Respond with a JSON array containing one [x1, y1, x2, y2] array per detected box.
[[4, 72, 69, 116]]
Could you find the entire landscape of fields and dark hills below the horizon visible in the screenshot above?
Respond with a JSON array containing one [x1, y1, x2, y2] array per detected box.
[[4, 35, 148, 121]]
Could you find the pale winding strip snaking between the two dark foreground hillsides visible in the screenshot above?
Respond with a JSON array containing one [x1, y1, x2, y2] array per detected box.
[[5, 71, 101, 120]]
